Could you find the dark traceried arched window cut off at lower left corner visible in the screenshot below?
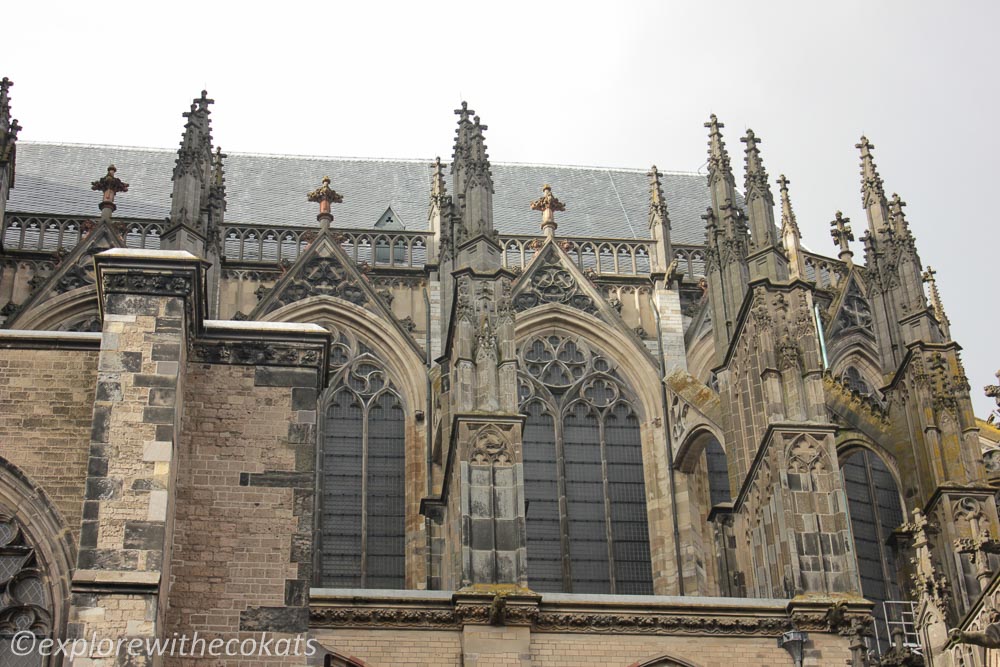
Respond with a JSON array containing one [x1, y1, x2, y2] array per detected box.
[[0, 508, 52, 667]]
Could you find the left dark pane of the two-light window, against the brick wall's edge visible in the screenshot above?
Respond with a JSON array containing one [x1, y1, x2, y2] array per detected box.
[[321, 389, 364, 588]]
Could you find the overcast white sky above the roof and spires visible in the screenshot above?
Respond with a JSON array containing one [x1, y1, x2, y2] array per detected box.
[[7, 0, 1000, 417]]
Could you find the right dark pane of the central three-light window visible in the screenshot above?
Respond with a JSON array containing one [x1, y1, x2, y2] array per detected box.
[[604, 403, 653, 595]]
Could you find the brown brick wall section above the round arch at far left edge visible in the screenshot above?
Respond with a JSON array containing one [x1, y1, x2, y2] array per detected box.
[[0, 349, 98, 543]]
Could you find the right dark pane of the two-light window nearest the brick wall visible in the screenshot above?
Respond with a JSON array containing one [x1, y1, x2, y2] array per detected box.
[[365, 393, 406, 588]]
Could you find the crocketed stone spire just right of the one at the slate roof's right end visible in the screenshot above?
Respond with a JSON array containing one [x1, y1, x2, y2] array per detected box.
[[740, 129, 788, 281]]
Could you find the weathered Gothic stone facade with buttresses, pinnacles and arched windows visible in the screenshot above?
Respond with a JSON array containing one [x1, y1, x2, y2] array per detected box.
[[0, 80, 1000, 667]]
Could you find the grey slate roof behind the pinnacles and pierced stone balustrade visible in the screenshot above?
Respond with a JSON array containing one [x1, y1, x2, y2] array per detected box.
[[7, 141, 710, 245]]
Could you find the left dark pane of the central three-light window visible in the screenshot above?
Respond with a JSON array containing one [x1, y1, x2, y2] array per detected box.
[[523, 401, 563, 592]]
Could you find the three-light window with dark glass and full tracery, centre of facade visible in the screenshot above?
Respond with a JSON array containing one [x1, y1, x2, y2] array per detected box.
[[519, 336, 653, 595]]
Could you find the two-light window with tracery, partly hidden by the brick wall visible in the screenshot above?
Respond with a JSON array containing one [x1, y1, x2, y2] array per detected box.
[[319, 334, 406, 588]]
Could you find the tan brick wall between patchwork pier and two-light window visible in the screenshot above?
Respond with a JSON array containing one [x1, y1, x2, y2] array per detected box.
[[166, 363, 316, 665]]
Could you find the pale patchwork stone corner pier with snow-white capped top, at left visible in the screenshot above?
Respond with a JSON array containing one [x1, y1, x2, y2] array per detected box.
[[70, 249, 205, 665]]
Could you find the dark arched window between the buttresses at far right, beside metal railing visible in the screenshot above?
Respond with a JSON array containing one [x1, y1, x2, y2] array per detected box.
[[840, 449, 905, 648]]
